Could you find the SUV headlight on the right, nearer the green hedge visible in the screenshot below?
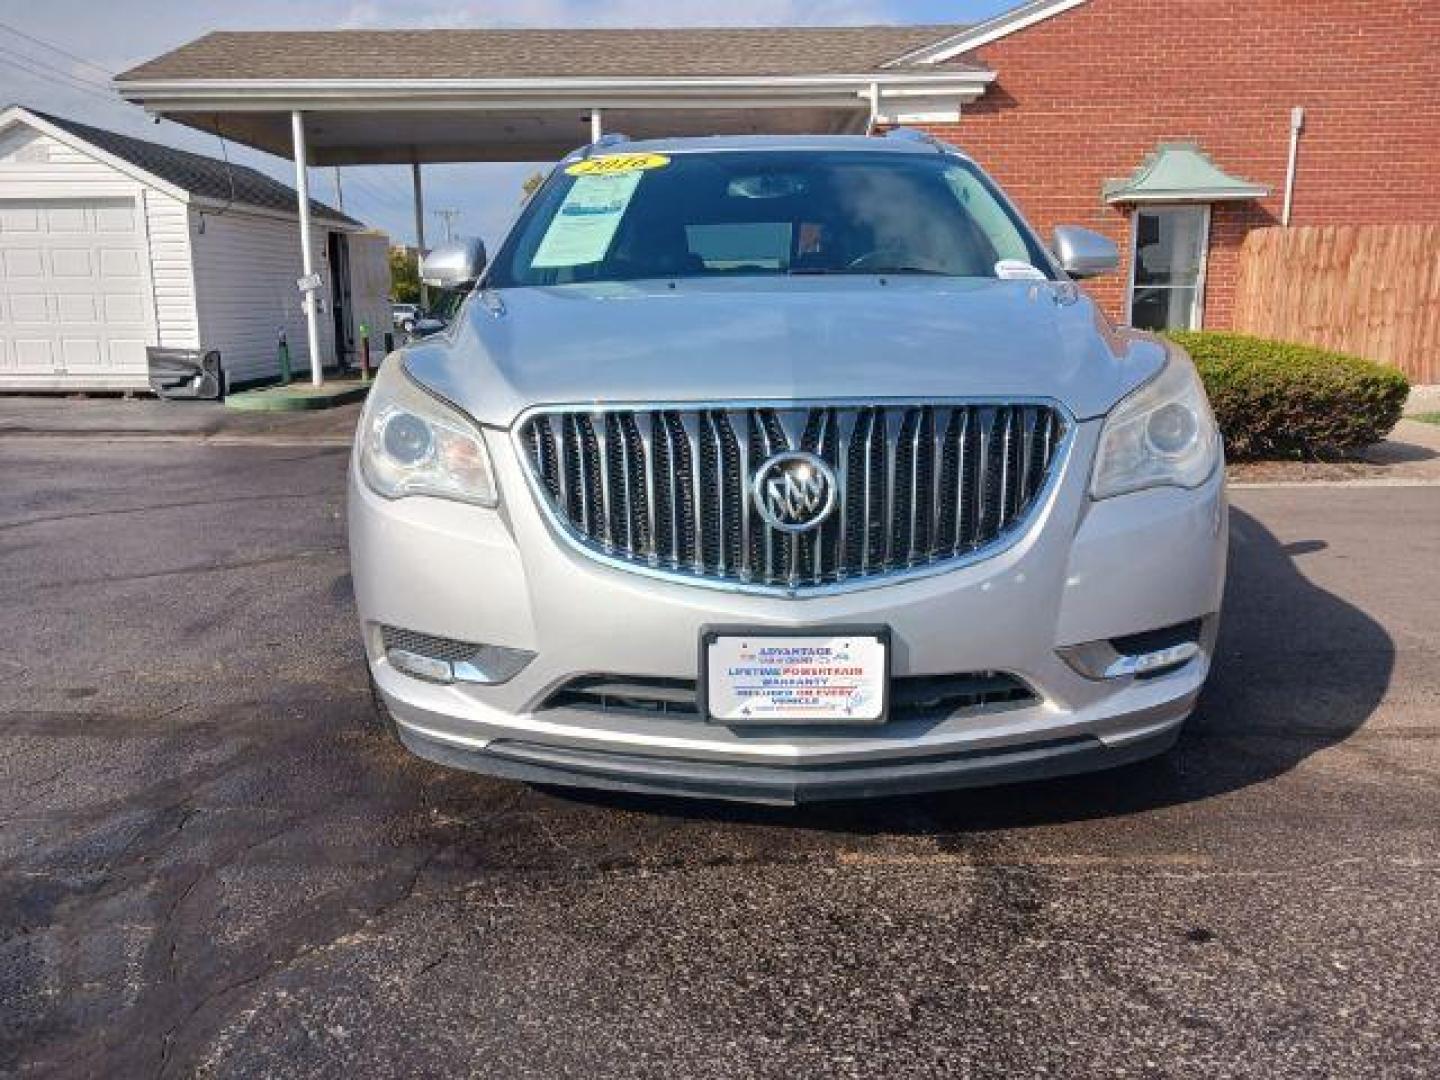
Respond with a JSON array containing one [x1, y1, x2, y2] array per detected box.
[[1090, 348, 1220, 498]]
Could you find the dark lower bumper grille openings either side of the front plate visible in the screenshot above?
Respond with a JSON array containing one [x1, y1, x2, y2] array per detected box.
[[540, 671, 1040, 721]]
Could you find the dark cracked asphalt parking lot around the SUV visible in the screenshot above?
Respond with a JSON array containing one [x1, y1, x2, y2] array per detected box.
[[0, 439, 1440, 1077]]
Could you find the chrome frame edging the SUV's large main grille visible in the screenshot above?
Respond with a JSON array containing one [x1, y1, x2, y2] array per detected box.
[[508, 395, 1079, 600]]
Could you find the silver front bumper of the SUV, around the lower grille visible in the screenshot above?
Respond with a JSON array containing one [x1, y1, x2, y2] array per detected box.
[[350, 422, 1225, 802]]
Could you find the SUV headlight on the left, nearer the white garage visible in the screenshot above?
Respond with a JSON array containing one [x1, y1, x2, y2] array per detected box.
[[357, 360, 500, 507]]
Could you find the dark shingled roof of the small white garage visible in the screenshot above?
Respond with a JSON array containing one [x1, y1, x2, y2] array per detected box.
[[22, 107, 363, 228]]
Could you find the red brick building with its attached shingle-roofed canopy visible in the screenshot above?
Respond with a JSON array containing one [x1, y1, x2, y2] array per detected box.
[[117, 0, 1440, 351]]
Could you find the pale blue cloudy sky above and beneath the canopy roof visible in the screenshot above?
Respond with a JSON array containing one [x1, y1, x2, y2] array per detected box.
[[0, 0, 1018, 246]]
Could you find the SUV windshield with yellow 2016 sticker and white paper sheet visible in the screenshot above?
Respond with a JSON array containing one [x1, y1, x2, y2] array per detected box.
[[488, 150, 1051, 288]]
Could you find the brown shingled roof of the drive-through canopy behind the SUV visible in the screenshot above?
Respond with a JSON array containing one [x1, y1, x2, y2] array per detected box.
[[118, 24, 984, 84]]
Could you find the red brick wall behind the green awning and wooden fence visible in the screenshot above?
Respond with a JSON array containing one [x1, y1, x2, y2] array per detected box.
[[910, 0, 1440, 328]]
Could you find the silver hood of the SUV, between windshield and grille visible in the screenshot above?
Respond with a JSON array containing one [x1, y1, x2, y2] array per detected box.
[[405, 276, 1165, 426]]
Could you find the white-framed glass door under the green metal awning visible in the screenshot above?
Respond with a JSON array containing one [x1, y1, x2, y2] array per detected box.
[[1126, 204, 1210, 330]]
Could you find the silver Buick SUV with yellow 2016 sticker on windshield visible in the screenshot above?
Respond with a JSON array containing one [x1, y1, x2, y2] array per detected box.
[[350, 132, 1227, 802]]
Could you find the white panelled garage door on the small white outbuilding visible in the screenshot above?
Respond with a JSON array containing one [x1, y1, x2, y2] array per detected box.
[[0, 199, 151, 389]]
